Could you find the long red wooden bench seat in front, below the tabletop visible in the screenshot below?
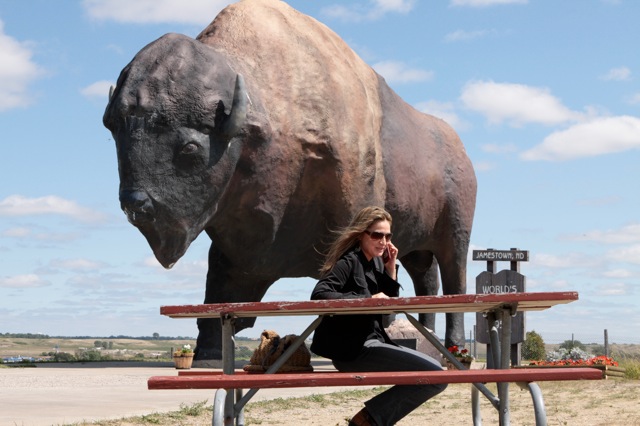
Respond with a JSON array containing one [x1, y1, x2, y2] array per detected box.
[[147, 368, 603, 390]]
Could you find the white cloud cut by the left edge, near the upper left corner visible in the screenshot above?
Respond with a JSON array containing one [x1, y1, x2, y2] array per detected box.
[[0, 21, 43, 111]]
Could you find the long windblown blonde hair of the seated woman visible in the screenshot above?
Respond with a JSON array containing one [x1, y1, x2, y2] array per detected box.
[[320, 206, 391, 276]]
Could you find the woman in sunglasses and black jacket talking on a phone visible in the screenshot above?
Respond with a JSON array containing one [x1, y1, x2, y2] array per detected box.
[[311, 207, 447, 426]]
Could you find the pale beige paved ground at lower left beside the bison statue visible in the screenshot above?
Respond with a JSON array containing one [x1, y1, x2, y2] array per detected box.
[[0, 363, 344, 426]]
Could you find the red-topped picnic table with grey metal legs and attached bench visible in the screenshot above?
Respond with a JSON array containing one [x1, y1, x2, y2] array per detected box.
[[148, 292, 603, 426]]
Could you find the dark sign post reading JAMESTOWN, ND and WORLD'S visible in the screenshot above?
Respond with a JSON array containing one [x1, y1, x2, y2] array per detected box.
[[473, 248, 529, 368]]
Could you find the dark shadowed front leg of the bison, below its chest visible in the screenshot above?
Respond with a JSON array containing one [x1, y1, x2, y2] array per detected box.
[[194, 246, 275, 361]]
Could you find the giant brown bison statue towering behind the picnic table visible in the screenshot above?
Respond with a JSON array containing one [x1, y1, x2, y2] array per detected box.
[[104, 0, 476, 360]]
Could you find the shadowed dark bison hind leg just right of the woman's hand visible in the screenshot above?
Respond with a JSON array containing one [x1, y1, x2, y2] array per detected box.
[[400, 250, 440, 330]]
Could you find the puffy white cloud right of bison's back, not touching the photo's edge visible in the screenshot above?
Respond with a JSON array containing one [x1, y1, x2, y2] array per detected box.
[[460, 81, 581, 126]]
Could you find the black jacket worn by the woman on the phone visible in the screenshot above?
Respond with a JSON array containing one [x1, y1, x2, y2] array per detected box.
[[311, 250, 400, 361]]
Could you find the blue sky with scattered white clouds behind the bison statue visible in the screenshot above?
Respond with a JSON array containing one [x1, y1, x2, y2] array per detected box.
[[0, 0, 640, 343]]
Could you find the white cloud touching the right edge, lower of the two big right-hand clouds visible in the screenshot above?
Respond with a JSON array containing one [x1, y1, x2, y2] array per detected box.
[[521, 115, 640, 161]]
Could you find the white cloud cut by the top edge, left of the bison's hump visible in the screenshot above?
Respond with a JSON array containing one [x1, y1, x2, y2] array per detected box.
[[82, 0, 229, 25]]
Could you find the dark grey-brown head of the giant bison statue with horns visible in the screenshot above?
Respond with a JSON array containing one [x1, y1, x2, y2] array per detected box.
[[103, 34, 248, 268]]
